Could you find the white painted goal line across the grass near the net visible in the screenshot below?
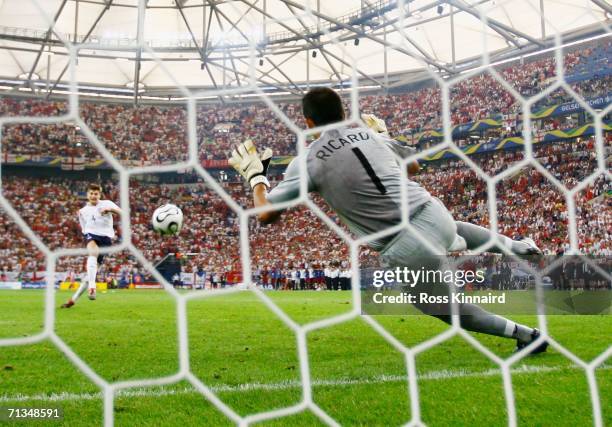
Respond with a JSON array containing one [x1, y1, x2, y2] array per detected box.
[[0, 365, 612, 403]]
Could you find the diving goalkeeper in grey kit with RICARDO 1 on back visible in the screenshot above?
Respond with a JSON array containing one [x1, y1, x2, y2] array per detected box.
[[229, 88, 547, 353]]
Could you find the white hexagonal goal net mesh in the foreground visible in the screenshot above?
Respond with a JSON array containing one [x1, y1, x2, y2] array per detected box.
[[0, 0, 612, 426]]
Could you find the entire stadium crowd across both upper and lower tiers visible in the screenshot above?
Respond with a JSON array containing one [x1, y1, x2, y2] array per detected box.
[[0, 41, 612, 288]]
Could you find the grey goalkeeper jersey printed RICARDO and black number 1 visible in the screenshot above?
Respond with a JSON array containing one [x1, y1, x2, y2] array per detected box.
[[268, 127, 431, 250]]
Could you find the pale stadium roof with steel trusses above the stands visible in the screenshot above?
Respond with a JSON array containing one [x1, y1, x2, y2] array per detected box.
[[0, 0, 612, 100]]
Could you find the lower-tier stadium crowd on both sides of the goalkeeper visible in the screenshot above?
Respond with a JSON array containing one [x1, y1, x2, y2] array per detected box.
[[0, 132, 612, 287]]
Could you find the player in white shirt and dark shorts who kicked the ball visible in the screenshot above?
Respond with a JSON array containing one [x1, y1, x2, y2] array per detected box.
[[62, 184, 121, 308]]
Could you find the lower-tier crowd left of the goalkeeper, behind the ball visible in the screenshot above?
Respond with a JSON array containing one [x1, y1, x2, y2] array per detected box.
[[0, 177, 348, 275]]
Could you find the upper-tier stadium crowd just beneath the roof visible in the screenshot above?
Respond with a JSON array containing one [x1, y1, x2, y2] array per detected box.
[[0, 40, 612, 165]]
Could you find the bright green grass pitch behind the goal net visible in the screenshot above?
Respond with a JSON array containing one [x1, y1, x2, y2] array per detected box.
[[0, 290, 612, 426]]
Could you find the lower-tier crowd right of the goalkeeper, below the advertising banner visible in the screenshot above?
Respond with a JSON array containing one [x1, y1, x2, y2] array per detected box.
[[415, 138, 612, 256]]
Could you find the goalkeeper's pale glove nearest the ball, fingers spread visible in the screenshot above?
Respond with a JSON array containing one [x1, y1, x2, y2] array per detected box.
[[229, 139, 272, 188]]
